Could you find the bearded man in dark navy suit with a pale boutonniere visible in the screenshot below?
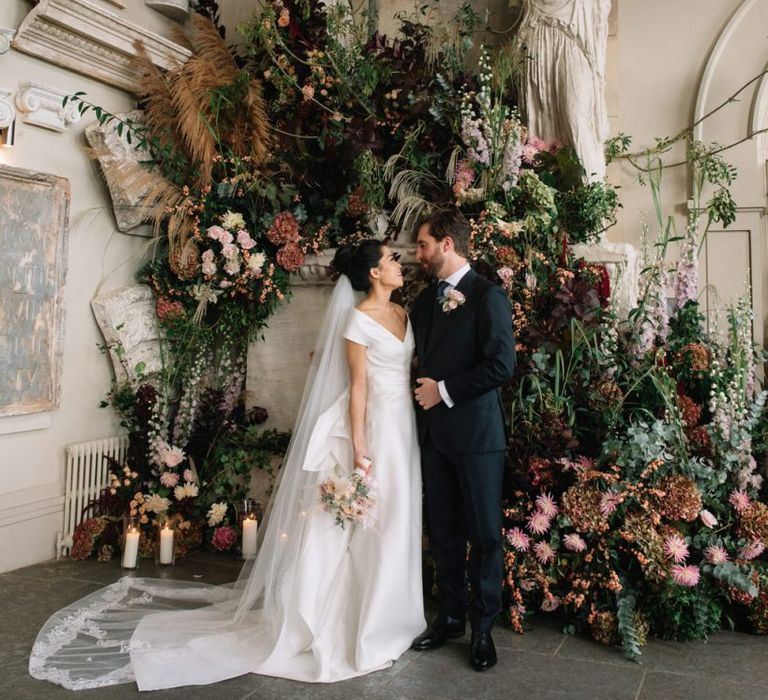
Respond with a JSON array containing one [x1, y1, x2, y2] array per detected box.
[[411, 210, 515, 671]]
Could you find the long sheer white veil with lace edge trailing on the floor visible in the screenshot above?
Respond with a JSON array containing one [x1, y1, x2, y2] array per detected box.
[[29, 276, 358, 690]]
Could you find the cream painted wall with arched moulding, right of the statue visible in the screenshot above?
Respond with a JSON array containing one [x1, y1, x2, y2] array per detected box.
[[609, 0, 768, 343]]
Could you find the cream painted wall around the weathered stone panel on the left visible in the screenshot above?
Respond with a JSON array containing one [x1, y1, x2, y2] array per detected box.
[[0, 0, 182, 572]]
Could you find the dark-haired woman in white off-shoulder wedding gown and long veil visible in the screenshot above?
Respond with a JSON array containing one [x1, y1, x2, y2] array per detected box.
[[29, 240, 425, 690]]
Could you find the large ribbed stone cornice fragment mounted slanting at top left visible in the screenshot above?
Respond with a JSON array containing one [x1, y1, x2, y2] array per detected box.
[[12, 0, 191, 92]]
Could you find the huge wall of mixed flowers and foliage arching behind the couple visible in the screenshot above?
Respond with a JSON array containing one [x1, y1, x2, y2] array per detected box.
[[61, 0, 768, 659]]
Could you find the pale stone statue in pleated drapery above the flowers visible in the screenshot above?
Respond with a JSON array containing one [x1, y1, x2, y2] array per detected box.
[[520, 0, 611, 180]]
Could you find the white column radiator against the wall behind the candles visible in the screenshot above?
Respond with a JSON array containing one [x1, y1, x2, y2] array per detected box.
[[56, 435, 128, 559]]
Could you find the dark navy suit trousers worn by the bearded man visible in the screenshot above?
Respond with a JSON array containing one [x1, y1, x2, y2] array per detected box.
[[421, 431, 504, 632]]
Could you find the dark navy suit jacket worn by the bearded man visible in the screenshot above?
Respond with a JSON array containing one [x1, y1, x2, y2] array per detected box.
[[411, 270, 515, 454]]
